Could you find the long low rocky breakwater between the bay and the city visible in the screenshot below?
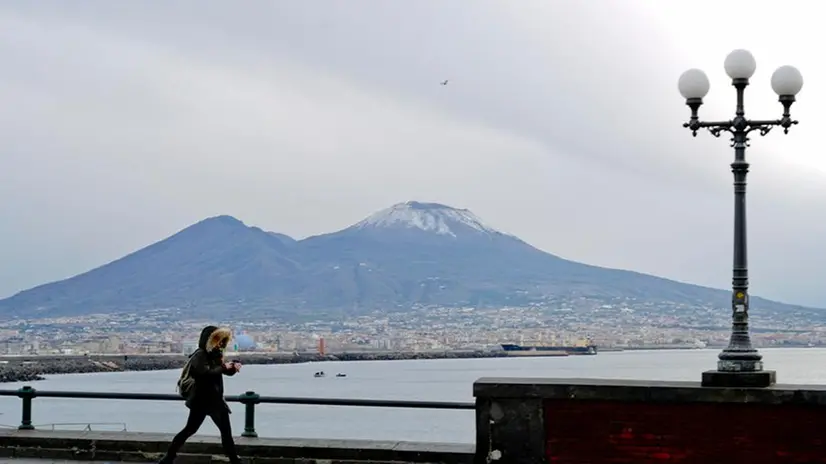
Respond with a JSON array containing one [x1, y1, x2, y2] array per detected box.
[[0, 351, 505, 383]]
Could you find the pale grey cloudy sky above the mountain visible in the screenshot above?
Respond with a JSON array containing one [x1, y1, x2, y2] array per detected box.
[[0, 0, 826, 307]]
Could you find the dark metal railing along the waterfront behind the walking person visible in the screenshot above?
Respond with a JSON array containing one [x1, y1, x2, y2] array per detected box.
[[0, 385, 476, 438]]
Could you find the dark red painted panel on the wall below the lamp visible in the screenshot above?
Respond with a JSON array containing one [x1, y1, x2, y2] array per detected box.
[[545, 400, 826, 464]]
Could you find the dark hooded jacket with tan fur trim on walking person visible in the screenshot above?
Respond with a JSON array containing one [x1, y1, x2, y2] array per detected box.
[[186, 325, 236, 413]]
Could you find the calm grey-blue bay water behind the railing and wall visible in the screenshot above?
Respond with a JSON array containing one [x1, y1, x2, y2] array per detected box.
[[0, 348, 826, 443]]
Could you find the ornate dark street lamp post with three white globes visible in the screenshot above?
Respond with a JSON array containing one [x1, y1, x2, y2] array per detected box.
[[678, 50, 803, 387]]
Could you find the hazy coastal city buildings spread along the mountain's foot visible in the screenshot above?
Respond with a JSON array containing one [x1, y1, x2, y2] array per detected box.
[[0, 300, 826, 355]]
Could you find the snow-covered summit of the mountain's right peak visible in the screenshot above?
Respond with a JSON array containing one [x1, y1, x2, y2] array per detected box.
[[353, 201, 505, 237]]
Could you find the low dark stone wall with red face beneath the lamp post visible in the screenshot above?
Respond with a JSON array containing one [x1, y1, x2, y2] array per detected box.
[[474, 379, 826, 464]]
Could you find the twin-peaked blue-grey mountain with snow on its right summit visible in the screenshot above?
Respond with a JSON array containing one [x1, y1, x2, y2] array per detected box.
[[0, 201, 816, 317]]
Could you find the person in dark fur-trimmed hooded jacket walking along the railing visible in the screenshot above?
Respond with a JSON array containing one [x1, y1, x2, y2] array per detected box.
[[159, 326, 241, 464]]
